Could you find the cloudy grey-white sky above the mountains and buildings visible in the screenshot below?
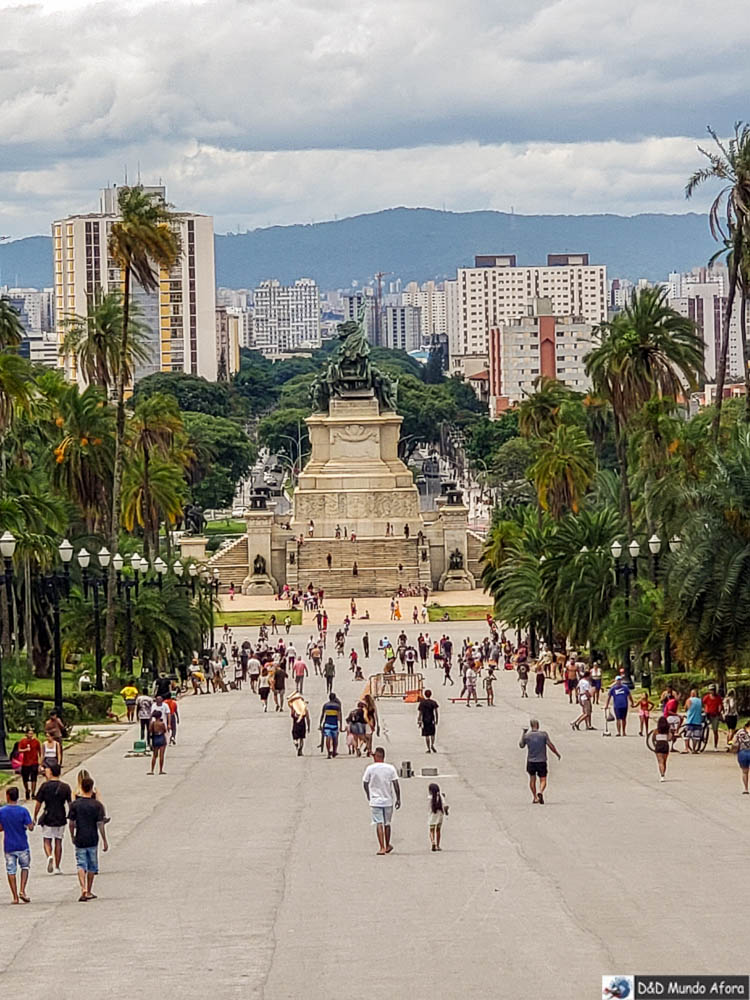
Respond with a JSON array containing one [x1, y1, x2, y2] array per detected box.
[[0, 0, 750, 236]]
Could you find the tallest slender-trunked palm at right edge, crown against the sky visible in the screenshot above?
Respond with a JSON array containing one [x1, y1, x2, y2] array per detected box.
[[685, 122, 750, 441]]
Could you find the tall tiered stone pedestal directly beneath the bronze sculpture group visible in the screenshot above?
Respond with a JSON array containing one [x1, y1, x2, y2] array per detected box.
[[293, 392, 422, 538]]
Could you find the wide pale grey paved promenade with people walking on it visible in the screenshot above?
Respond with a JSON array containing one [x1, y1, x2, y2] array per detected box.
[[0, 621, 750, 1000]]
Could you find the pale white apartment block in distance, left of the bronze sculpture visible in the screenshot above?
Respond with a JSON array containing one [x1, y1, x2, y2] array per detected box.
[[252, 278, 321, 357]]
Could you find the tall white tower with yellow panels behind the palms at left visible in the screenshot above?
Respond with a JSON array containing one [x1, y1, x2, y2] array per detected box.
[[52, 187, 217, 382]]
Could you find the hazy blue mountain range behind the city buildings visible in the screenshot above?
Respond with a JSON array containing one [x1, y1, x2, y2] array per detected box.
[[0, 208, 716, 289]]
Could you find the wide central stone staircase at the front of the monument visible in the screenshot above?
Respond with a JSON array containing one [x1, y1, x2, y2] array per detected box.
[[297, 536, 431, 597]]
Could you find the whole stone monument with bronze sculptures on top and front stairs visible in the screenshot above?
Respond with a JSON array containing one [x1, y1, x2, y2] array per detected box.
[[203, 316, 481, 597]]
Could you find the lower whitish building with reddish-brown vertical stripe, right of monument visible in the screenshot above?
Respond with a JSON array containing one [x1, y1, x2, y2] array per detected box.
[[489, 298, 595, 415]]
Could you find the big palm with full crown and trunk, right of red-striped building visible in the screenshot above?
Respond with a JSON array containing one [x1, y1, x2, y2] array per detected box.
[[585, 288, 704, 536]]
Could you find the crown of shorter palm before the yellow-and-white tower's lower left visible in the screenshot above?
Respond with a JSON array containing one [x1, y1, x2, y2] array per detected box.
[[62, 290, 150, 395]]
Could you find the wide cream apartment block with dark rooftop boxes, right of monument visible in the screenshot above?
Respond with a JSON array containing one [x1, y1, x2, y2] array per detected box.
[[446, 253, 607, 371]]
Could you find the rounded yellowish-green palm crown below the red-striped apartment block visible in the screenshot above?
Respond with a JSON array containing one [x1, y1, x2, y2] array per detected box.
[[529, 424, 596, 521]]
